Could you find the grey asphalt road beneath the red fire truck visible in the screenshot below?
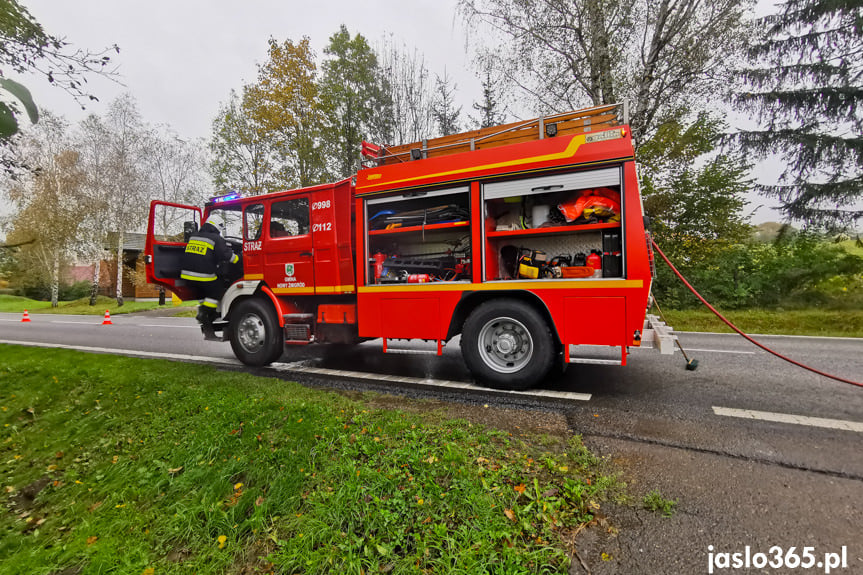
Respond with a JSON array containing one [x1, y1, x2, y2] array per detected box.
[[0, 314, 863, 574]]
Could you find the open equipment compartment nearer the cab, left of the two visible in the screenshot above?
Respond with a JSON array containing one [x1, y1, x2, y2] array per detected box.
[[364, 185, 471, 285]]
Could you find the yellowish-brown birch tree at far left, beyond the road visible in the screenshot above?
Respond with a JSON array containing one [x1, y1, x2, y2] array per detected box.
[[9, 114, 84, 307]]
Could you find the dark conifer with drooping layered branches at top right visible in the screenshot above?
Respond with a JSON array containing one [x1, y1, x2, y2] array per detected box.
[[734, 0, 863, 227]]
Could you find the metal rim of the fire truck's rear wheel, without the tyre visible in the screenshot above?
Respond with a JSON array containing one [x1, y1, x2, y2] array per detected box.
[[477, 317, 533, 373]]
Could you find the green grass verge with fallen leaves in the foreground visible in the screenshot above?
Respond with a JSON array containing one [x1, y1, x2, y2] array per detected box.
[[0, 346, 621, 575]]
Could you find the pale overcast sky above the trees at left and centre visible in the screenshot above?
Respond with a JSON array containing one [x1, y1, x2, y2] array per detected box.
[[18, 0, 480, 142]]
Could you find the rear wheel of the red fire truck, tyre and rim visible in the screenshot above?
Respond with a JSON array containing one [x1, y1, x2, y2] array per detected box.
[[461, 299, 554, 390]]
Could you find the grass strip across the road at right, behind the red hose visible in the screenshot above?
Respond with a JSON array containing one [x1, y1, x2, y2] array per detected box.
[[651, 309, 863, 337]]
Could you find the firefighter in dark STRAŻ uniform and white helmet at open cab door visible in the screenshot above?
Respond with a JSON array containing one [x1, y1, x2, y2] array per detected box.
[[180, 214, 240, 339]]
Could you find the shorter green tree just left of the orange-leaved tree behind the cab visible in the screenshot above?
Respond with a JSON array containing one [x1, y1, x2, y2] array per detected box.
[[210, 86, 279, 196]]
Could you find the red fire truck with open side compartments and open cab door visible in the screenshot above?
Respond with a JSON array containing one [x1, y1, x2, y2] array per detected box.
[[146, 105, 652, 389]]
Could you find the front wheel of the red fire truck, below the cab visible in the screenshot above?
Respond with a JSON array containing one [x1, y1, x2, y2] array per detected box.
[[230, 299, 285, 366]]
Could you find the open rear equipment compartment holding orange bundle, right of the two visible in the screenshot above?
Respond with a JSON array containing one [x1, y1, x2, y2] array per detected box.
[[482, 167, 625, 281]]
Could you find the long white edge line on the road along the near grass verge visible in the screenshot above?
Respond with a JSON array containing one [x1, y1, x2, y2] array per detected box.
[[0, 339, 590, 401]]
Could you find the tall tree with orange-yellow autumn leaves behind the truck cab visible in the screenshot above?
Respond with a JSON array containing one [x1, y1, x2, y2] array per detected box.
[[250, 38, 325, 187]]
